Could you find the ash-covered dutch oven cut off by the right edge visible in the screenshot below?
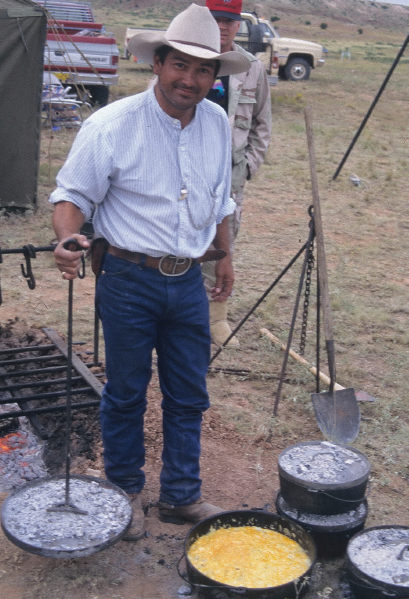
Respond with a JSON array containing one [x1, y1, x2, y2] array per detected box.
[[346, 525, 409, 599]]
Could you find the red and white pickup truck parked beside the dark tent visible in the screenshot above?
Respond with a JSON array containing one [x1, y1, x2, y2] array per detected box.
[[35, 0, 119, 106]]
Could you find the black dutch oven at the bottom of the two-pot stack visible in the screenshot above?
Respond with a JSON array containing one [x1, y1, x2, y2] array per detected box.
[[275, 492, 368, 558]]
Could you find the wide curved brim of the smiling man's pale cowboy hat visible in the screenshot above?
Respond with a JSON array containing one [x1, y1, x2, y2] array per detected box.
[[128, 31, 250, 77]]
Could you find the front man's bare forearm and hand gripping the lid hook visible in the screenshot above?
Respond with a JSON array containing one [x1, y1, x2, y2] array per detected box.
[[53, 202, 90, 280]]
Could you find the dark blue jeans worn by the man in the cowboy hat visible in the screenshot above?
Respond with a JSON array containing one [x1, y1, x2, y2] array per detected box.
[[96, 254, 210, 505]]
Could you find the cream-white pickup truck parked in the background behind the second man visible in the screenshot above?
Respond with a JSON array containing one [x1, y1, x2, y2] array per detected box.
[[234, 13, 325, 81]]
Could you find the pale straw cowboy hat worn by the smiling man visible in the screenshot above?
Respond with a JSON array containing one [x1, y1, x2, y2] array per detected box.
[[128, 4, 250, 77]]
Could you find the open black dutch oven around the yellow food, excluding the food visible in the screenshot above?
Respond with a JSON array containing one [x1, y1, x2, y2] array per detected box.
[[179, 510, 316, 599]]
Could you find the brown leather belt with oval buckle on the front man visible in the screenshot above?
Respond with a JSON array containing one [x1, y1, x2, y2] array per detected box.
[[107, 245, 226, 277]]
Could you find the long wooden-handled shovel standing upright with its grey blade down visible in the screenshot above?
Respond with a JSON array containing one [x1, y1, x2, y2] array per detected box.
[[304, 106, 361, 445]]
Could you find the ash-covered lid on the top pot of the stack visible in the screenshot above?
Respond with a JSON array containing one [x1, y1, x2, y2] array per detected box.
[[278, 441, 370, 486]]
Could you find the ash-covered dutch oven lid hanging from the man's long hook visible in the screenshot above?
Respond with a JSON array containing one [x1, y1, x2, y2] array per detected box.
[[1, 475, 132, 557]]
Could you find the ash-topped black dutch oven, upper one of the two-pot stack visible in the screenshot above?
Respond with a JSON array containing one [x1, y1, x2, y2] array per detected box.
[[278, 441, 370, 515]]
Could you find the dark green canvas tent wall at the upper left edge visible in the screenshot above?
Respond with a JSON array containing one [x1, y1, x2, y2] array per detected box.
[[0, 0, 47, 208]]
